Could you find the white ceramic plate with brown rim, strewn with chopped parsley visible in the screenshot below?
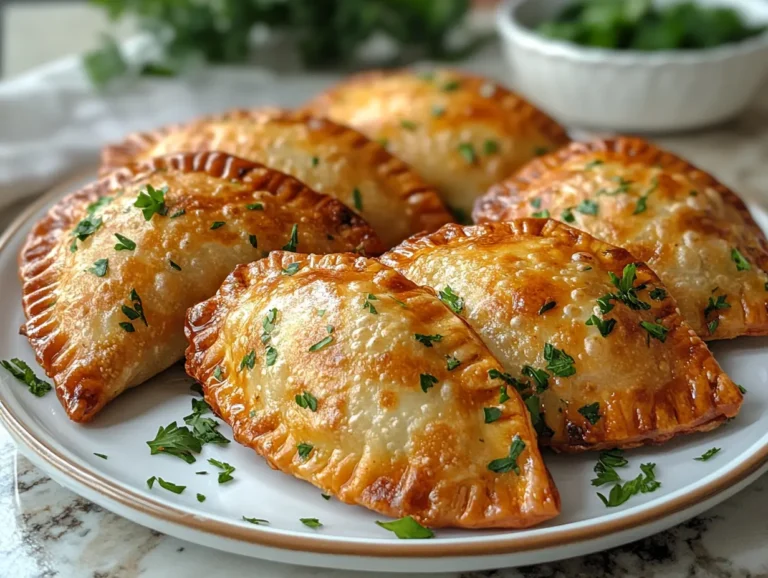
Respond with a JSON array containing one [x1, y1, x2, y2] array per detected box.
[[0, 169, 768, 572]]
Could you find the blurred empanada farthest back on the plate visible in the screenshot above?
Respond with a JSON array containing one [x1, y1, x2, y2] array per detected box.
[[307, 70, 569, 219]]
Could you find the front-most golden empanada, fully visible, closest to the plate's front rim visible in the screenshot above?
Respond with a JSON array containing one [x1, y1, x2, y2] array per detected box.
[[186, 252, 559, 528]]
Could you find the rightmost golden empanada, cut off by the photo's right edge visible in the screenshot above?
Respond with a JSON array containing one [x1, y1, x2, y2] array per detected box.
[[474, 138, 768, 339]]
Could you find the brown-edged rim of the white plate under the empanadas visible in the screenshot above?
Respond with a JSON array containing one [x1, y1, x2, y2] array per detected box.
[[0, 165, 768, 558]]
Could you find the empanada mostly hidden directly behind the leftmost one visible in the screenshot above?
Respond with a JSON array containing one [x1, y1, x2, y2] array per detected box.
[[102, 109, 451, 247]]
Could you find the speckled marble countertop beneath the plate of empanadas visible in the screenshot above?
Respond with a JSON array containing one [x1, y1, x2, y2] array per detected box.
[[0, 83, 768, 578]]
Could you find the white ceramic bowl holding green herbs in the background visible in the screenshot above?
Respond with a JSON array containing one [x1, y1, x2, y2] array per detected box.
[[497, 0, 768, 132]]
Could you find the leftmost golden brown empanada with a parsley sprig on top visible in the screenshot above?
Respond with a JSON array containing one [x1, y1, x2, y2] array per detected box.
[[19, 153, 381, 422]]
